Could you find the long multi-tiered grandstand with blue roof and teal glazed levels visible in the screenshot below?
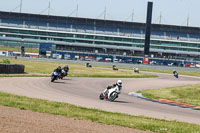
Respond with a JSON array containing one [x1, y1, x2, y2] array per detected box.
[[0, 11, 200, 64]]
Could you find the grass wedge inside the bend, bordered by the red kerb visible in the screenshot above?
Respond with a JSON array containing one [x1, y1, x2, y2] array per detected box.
[[139, 84, 200, 106]]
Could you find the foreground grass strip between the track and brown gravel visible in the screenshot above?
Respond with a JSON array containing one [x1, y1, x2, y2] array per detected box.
[[0, 92, 200, 133]]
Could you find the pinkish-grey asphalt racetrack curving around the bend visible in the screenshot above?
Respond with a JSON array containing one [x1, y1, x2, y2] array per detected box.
[[0, 73, 200, 124]]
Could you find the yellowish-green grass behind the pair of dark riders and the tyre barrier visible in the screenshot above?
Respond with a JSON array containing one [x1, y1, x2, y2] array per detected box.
[[0, 59, 157, 78]]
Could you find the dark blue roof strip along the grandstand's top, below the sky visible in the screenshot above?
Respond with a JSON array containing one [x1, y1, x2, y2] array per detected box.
[[0, 11, 200, 34]]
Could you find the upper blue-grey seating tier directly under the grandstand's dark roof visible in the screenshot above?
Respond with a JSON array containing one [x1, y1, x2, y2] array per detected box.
[[1, 18, 200, 42]]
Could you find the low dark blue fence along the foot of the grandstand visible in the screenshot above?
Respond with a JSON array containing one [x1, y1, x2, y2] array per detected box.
[[52, 51, 198, 66]]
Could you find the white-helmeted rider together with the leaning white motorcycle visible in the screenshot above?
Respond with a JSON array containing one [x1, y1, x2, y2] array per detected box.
[[99, 80, 122, 101]]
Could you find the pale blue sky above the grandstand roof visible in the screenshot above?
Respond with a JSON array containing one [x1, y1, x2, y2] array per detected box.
[[0, 0, 200, 27]]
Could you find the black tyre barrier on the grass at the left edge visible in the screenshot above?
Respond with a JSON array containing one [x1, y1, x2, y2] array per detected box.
[[0, 64, 25, 74]]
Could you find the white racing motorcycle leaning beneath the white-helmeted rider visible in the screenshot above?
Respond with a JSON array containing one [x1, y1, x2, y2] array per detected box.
[[99, 85, 121, 101]]
